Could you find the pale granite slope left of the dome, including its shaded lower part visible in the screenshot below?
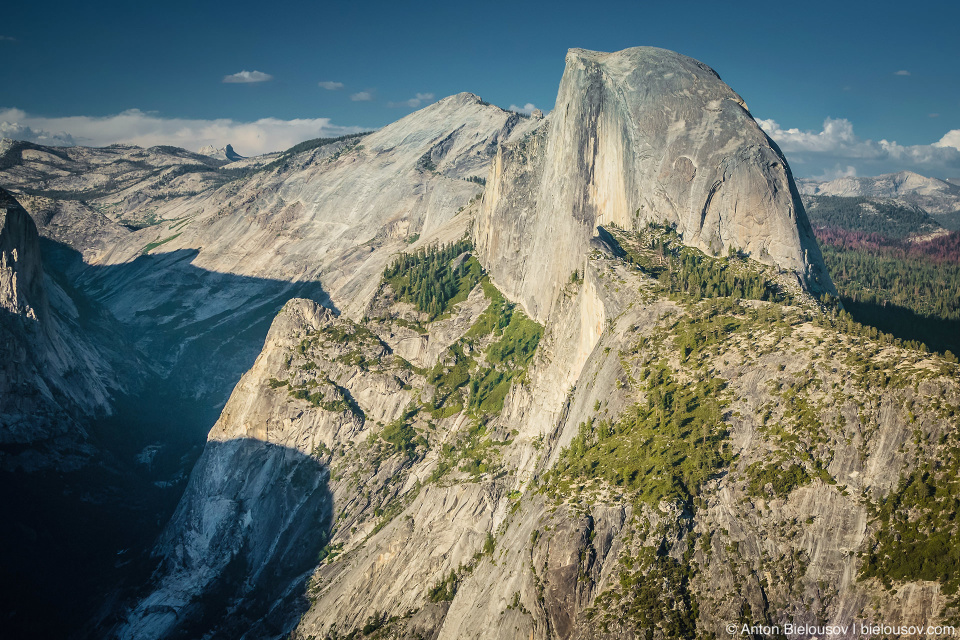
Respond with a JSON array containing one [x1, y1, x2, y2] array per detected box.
[[0, 93, 533, 404]]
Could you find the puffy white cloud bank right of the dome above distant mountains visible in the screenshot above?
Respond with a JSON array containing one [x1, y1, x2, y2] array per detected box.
[[757, 118, 960, 175]]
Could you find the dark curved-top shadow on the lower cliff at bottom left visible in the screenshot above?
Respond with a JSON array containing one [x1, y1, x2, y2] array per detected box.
[[101, 438, 333, 639]]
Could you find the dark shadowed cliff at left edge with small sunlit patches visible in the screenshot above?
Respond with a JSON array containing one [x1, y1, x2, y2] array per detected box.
[[0, 189, 120, 471]]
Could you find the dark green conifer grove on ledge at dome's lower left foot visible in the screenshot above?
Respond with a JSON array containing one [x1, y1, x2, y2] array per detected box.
[[383, 240, 483, 321]]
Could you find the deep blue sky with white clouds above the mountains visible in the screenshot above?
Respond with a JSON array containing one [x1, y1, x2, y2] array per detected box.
[[0, 0, 960, 177]]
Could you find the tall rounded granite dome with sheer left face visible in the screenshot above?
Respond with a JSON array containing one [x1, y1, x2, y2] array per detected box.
[[476, 47, 833, 320]]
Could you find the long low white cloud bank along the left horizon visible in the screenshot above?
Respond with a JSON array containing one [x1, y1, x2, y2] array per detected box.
[[0, 108, 363, 156]]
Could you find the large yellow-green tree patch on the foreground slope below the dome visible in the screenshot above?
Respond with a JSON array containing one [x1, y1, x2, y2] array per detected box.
[[548, 363, 731, 504]]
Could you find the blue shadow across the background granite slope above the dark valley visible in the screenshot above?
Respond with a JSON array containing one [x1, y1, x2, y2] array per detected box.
[[41, 239, 339, 407]]
